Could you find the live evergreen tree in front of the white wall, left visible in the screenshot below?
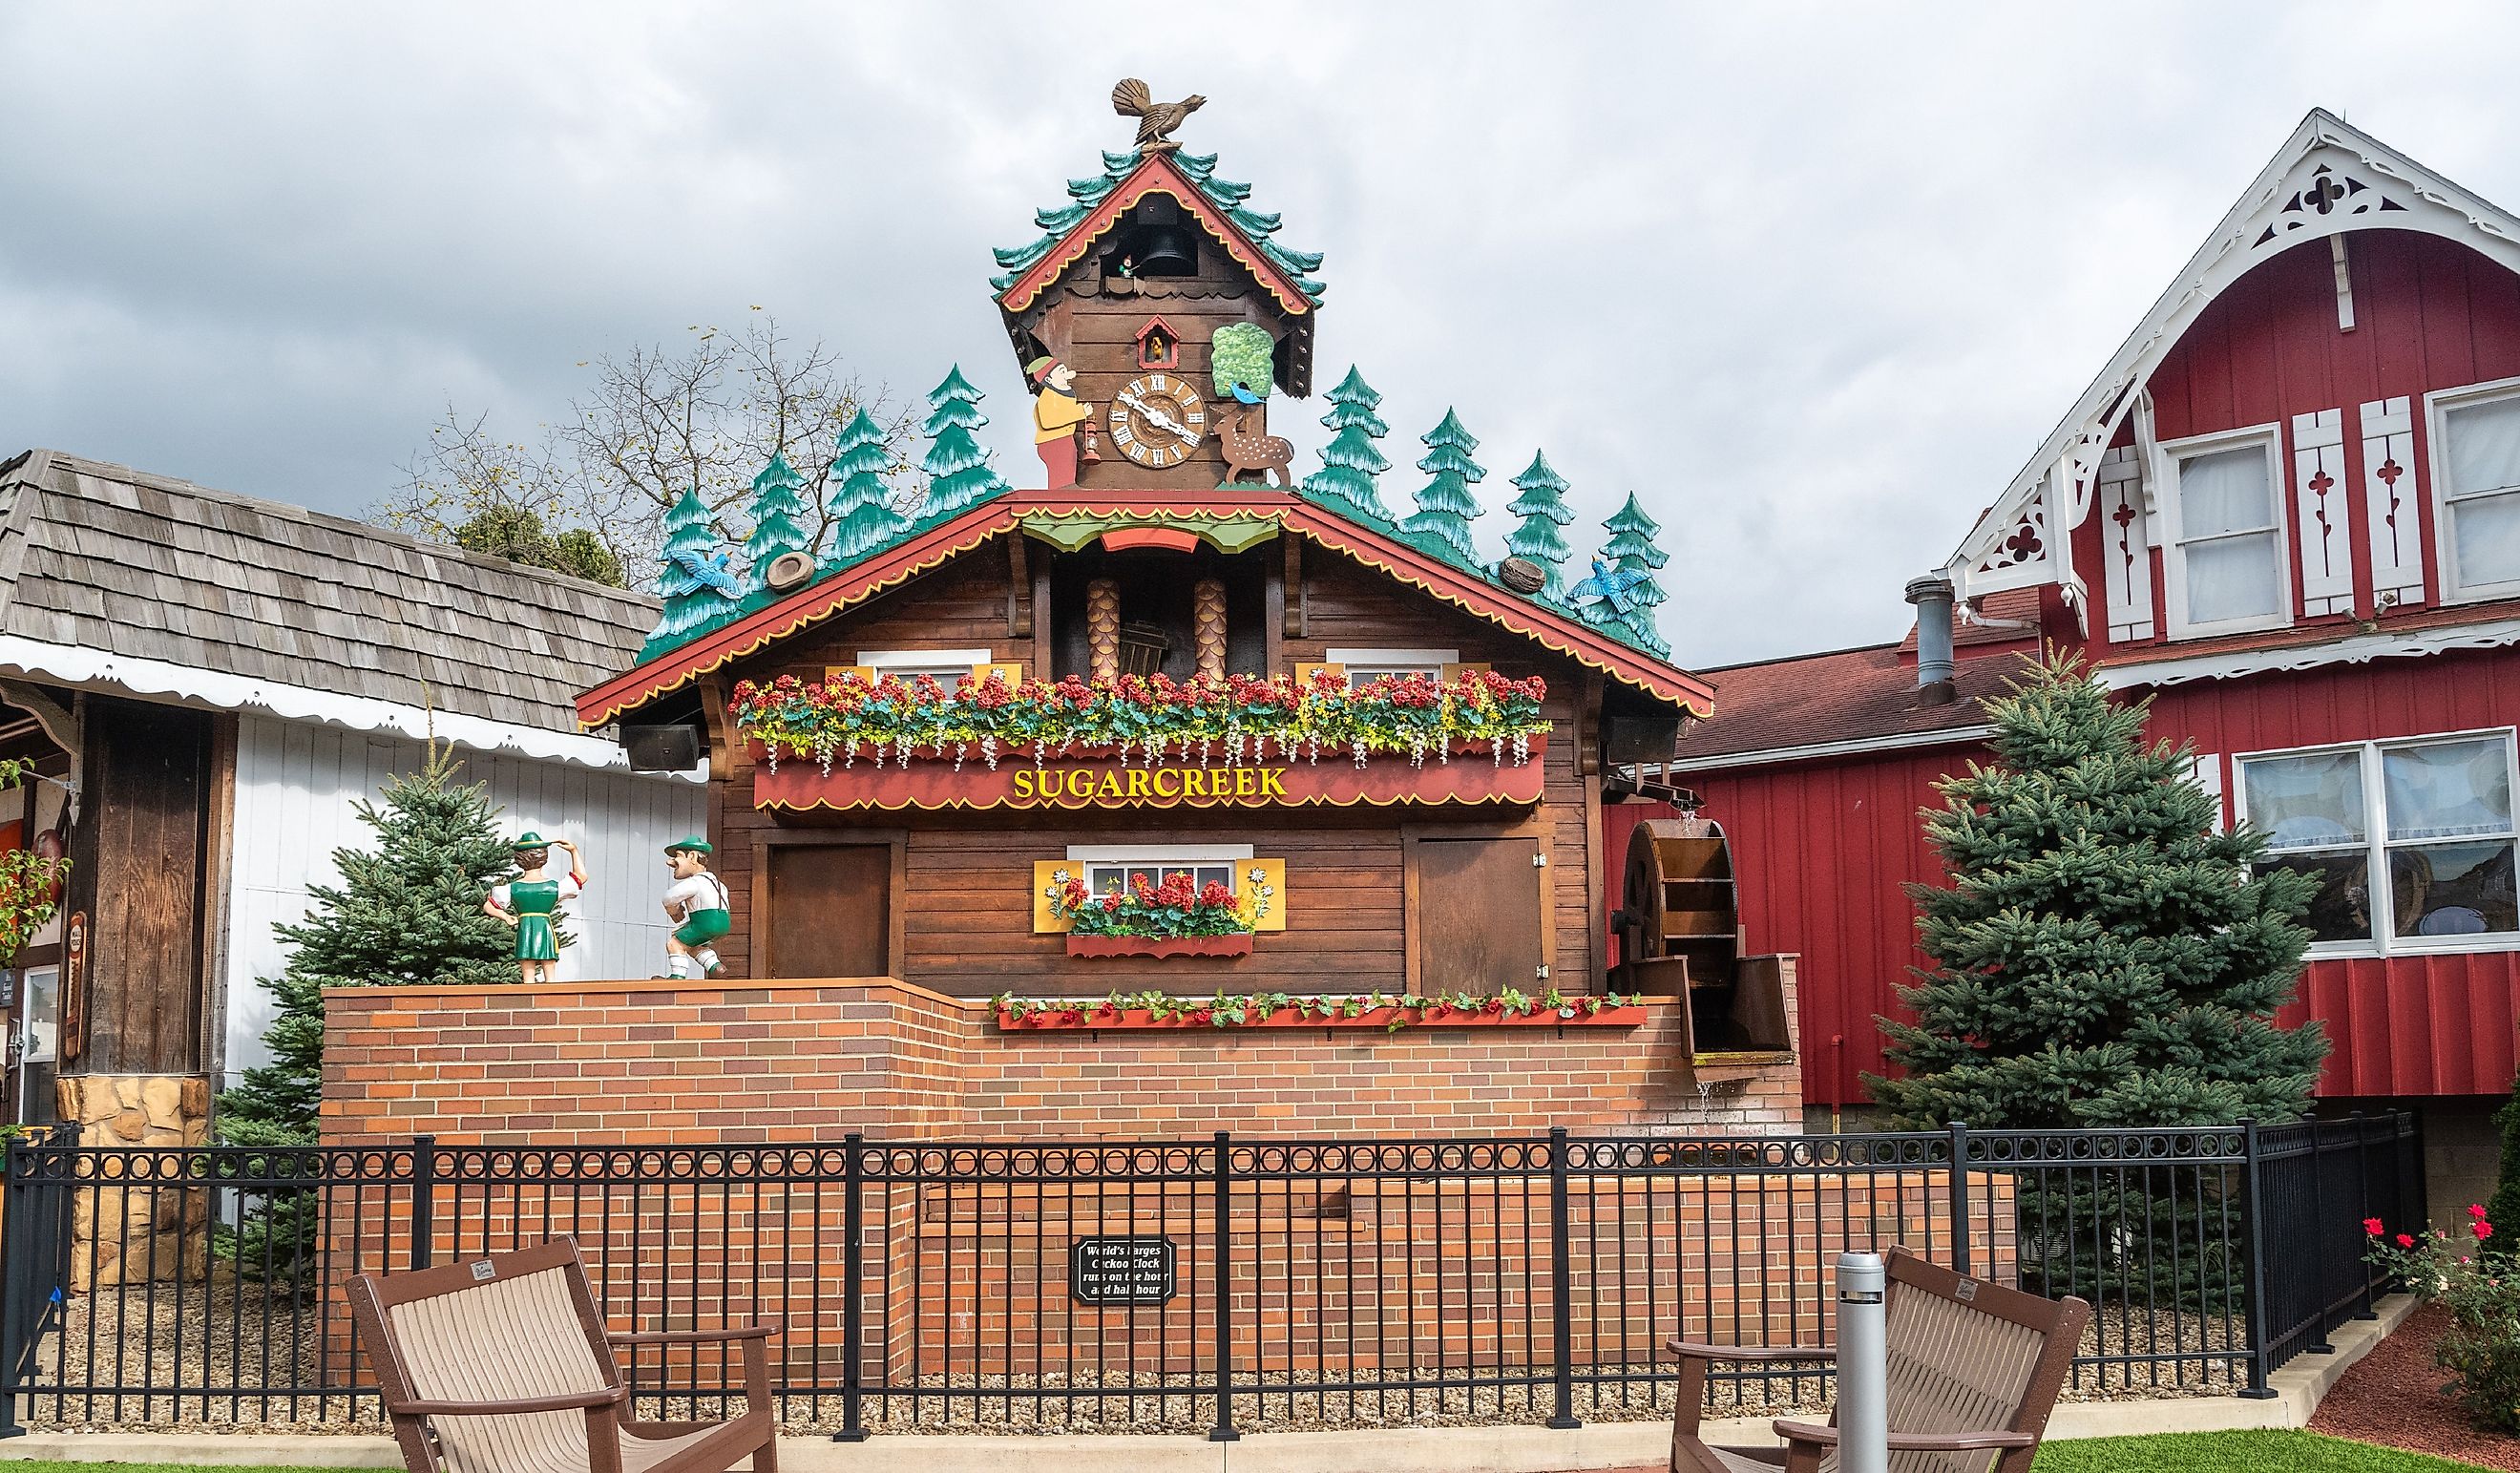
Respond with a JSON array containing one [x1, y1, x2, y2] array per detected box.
[[217, 749, 516, 1279]]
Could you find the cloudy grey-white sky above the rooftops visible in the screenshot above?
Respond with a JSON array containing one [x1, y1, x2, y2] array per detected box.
[[0, 0, 2520, 666]]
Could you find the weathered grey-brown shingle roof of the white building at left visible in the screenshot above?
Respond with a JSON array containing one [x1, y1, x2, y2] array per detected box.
[[0, 449, 658, 731]]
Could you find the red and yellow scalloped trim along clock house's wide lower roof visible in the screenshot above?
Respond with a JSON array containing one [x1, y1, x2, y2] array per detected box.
[[578, 487, 1713, 726]]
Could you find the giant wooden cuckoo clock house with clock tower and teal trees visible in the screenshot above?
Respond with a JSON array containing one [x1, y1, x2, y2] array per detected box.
[[532, 83, 1799, 1140]]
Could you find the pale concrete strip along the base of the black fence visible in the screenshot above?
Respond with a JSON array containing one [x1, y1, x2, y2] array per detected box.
[[0, 1294, 2414, 1473]]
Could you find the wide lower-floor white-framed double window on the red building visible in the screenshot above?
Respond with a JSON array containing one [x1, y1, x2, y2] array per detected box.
[[2237, 731, 2520, 956]]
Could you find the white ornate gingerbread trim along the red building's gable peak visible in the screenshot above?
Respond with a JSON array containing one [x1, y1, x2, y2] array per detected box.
[[1945, 109, 2520, 600]]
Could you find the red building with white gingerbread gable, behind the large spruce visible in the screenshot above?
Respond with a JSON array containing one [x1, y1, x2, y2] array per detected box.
[[1678, 111, 2520, 1201]]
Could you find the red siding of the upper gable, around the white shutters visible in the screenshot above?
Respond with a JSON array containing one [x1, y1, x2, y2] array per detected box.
[[2074, 229, 2520, 659]]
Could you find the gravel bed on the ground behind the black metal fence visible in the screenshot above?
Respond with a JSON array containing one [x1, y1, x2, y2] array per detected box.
[[28, 1281, 2247, 1432]]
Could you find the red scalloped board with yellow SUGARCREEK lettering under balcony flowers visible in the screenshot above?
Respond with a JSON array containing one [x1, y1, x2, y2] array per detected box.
[[753, 737, 1547, 810]]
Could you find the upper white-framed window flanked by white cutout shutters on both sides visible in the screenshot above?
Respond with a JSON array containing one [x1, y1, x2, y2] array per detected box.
[[2162, 424, 2291, 636]]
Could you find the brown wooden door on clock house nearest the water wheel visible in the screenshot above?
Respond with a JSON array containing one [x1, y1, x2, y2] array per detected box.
[[1409, 837, 1550, 997]]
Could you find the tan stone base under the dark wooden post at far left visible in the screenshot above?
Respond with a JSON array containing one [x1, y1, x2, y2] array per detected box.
[[52, 1075, 209, 1292]]
